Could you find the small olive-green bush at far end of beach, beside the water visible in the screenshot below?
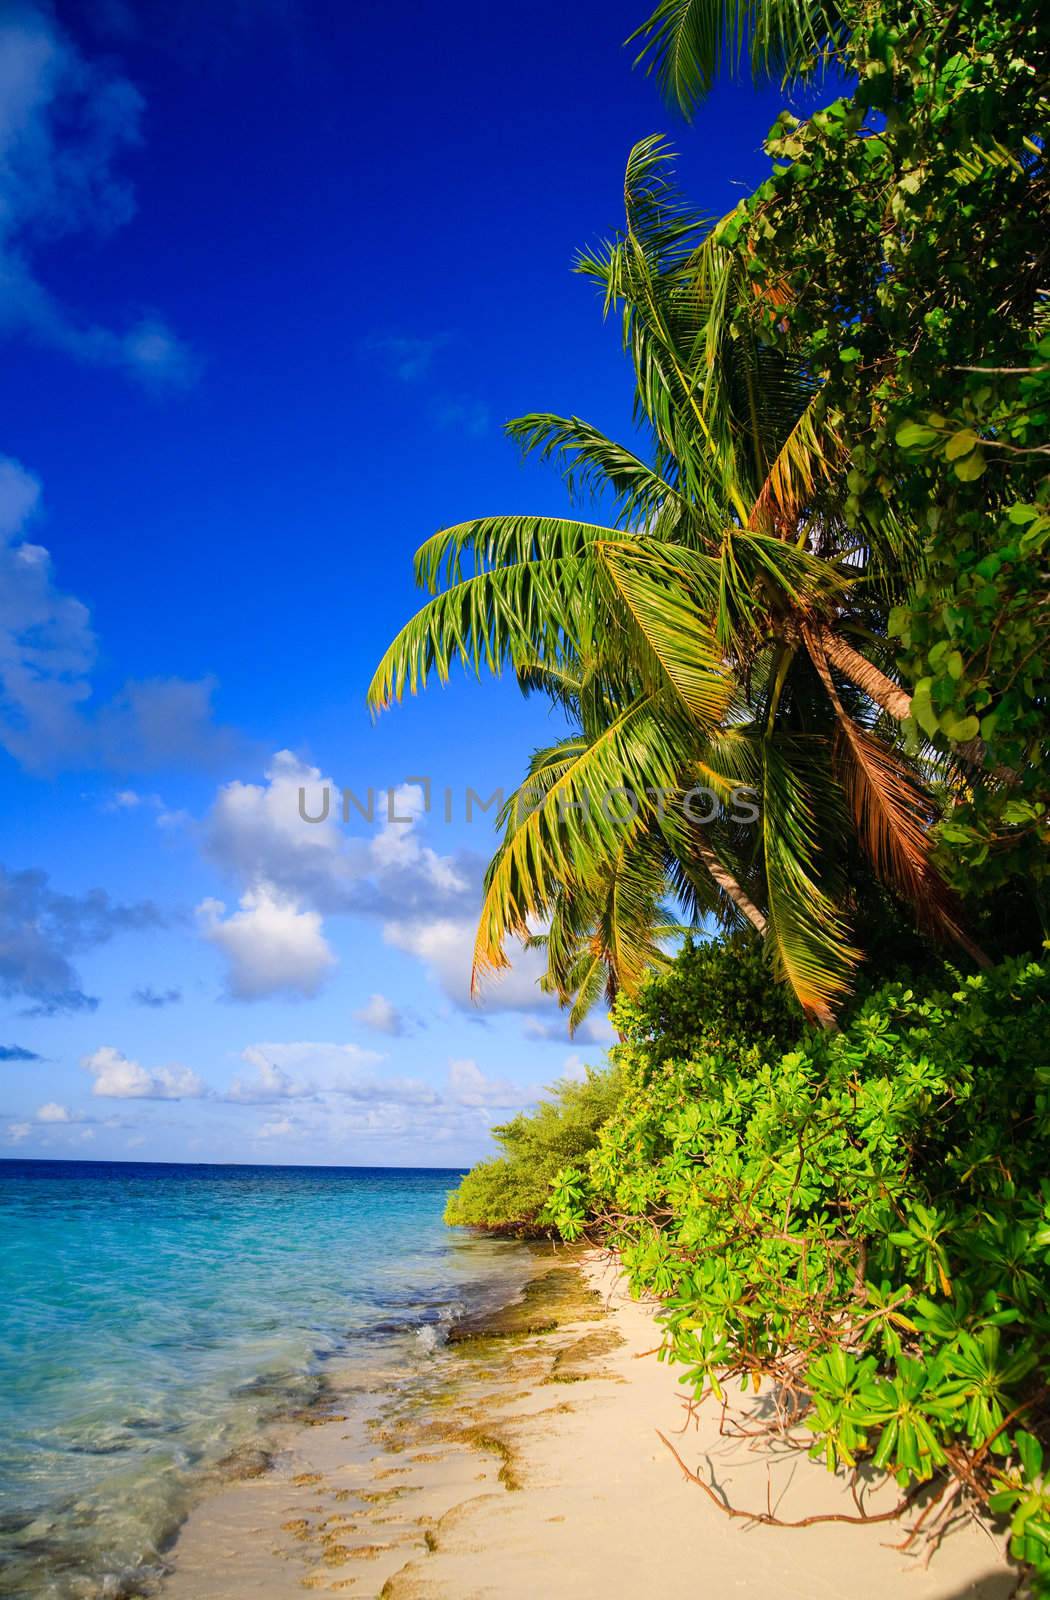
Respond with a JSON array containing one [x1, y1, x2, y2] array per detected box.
[[445, 1067, 619, 1234]]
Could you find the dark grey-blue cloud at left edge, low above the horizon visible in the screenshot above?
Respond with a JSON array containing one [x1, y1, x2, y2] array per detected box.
[[0, 867, 165, 1011]]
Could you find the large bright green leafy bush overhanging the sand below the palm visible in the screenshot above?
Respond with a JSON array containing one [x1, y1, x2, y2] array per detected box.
[[551, 960, 1050, 1592]]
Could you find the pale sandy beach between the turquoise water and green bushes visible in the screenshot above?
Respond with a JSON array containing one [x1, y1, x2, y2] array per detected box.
[[163, 1253, 1013, 1600]]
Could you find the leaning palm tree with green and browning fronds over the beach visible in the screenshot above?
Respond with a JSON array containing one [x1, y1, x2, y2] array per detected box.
[[370, 139, 960, 1022]]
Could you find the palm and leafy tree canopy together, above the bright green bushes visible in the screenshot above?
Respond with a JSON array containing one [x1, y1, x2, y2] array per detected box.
[[371, 0, 1050, 1024]]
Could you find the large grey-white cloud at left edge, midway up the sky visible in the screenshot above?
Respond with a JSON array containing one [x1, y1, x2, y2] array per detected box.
[[0, 456, 240, 777]]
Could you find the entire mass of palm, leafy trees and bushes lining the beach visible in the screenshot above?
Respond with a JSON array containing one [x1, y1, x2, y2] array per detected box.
[[371, 0, 1050, 1594]]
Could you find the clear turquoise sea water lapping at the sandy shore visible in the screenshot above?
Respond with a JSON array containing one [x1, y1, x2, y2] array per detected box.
[[0, 1162, 520, 1600]]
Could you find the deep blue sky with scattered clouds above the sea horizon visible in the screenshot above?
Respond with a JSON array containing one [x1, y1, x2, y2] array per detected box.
[[0, 0, 819, 1165]]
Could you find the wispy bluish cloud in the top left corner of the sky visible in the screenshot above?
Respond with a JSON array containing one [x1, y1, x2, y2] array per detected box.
[[0, 0, 194, 387]]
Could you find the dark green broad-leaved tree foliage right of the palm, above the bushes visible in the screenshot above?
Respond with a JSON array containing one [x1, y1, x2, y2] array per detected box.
[[717, 0, 1050, 918]]
